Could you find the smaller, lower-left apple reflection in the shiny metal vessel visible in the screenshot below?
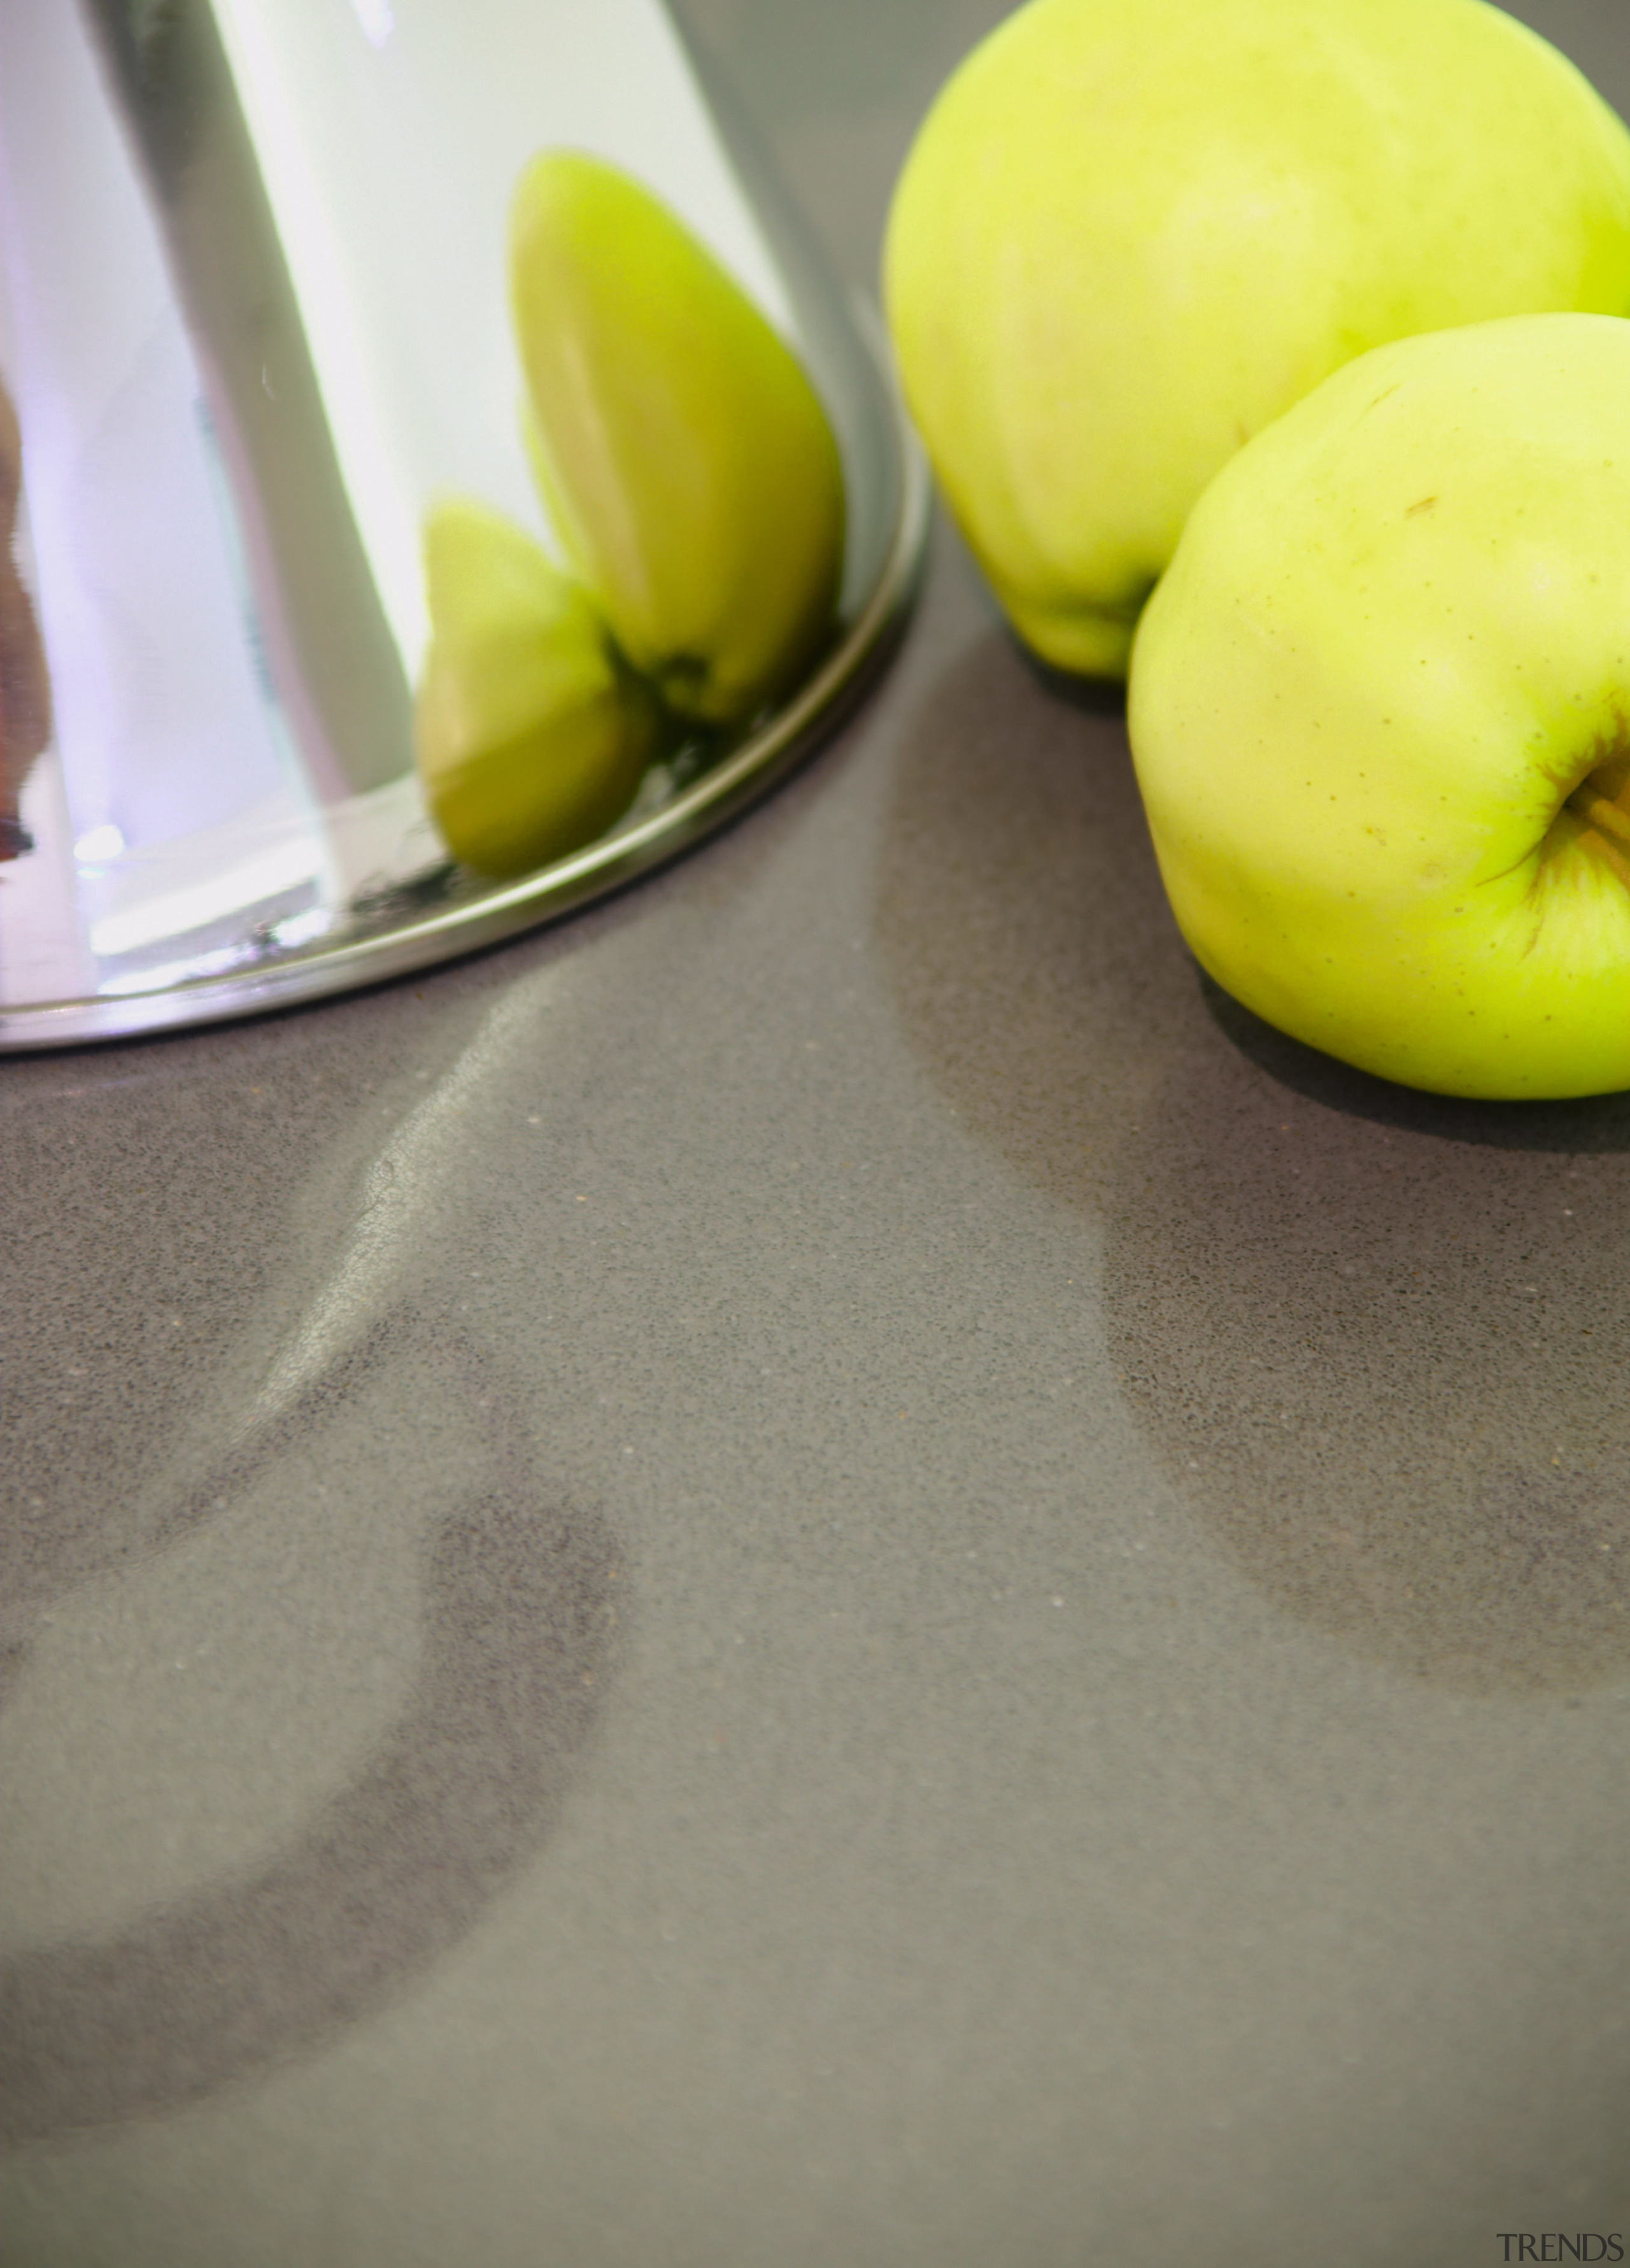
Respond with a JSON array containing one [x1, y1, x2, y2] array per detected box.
[[415, 499, 662, 875]]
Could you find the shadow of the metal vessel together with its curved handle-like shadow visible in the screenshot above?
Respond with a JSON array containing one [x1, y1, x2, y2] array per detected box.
[[0, 971, 626, 2143]]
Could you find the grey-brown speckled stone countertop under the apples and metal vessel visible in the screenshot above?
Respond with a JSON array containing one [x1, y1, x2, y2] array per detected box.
[[0, 0, 1630, 2268]]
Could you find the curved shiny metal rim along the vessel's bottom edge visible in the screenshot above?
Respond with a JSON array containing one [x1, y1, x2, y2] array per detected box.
[[0, 351, 932, 1052]]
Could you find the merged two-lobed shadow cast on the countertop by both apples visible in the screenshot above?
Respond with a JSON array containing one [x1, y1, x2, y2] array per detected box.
[[877, 635, 1630, 1696]]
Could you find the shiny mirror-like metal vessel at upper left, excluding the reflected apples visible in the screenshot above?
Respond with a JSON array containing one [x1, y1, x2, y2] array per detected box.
[[0, 0, 925, 1048]]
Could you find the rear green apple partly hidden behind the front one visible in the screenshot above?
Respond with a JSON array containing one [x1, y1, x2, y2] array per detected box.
[[884, 0, 1630, 676]]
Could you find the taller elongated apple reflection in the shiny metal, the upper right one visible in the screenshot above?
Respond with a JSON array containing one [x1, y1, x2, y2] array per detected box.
[[510, 150, 844, 726]]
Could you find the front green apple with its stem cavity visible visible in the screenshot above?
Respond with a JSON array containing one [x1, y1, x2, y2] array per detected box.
[[1129, 315, 1630, 1098]]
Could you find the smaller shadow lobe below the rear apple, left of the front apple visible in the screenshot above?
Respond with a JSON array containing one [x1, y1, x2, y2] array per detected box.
[[875, 630, 1193, 1207]]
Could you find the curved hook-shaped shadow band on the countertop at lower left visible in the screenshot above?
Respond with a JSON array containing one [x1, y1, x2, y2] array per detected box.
[[0, 1320, 616, 2143]]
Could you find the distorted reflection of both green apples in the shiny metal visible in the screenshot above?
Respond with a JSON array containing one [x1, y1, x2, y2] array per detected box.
[[415, 150, 846, 877]]
